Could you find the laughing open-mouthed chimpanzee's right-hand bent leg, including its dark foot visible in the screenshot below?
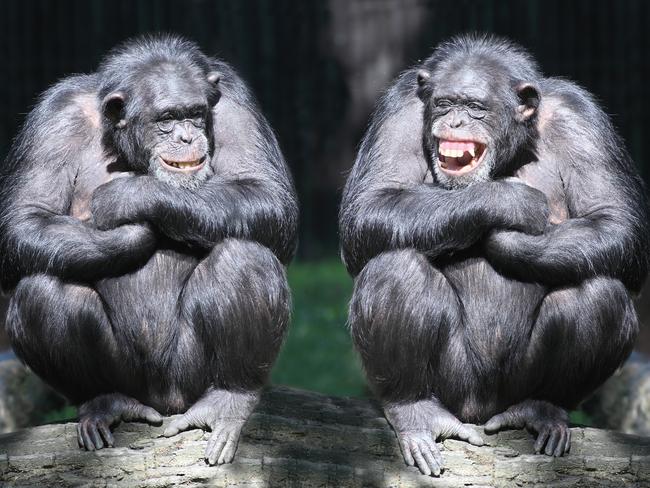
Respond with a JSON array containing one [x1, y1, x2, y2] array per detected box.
[[485, 277, 638, 456]]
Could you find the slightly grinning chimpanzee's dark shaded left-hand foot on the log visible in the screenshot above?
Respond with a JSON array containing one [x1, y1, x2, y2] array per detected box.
[[77, 393, 162, 451]]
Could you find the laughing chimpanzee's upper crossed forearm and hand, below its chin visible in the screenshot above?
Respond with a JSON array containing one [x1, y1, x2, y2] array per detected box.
[[341, 181, 547, 275]]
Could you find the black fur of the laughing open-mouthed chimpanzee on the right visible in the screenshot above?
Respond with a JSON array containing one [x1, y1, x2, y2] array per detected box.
[[340, 36, 649, 473]]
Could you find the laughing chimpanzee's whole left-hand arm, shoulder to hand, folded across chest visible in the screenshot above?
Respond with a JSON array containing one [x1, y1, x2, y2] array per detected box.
[[339, 72, 547, 275]]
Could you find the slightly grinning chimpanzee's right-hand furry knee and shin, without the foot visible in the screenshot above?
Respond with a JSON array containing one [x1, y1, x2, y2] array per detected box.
[[181, 239, 291, 389]]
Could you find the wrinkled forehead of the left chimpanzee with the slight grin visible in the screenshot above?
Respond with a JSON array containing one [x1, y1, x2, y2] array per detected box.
[[136, 63, 208, 111]]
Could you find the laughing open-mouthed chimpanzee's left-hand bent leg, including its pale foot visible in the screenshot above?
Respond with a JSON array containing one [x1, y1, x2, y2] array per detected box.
[[350, 249, 483, 475]]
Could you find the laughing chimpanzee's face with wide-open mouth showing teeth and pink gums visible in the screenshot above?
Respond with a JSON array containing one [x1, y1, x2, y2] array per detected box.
[[419, 56, 536, 188]]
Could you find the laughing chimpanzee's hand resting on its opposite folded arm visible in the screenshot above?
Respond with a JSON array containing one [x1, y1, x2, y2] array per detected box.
[[501, 178, 549, 235]]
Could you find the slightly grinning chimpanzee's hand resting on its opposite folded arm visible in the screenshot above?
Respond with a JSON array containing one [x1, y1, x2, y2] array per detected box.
[[90, 176, 146, 230]]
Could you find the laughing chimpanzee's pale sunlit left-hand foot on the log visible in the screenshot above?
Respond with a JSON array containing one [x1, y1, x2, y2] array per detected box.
[[384, 399, 483, 476]]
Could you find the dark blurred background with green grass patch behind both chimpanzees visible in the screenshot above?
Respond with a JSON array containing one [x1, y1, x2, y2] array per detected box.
[[0, 0, 650, 400]]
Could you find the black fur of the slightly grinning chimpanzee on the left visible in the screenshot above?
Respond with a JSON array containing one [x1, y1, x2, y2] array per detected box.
[[0, 37, 298, 462]]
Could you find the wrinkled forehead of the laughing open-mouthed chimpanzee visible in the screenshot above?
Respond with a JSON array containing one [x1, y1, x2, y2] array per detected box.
[[433, 56, 510, 100]]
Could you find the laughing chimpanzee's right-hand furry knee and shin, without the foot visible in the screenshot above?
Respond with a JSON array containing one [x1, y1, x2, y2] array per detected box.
[[529, 277, 639, 408]]
